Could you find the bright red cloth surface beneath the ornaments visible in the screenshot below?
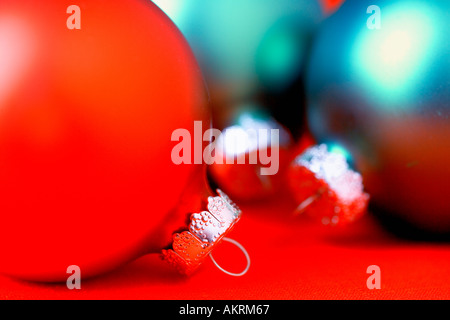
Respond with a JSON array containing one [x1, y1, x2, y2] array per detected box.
[[0, 192, 450, 300]]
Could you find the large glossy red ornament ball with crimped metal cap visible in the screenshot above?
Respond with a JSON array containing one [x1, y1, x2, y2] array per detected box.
[[0, 0, 243, 281]]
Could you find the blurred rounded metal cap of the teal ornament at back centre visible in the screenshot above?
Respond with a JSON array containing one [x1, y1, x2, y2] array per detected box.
[[208, 106, 293, 201]]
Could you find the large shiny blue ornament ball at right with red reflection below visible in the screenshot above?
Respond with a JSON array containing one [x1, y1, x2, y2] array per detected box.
[[307, 0, 450, 232]]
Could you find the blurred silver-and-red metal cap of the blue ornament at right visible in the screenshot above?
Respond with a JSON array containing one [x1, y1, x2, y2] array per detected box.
[[288, 144, 369, 225]]
